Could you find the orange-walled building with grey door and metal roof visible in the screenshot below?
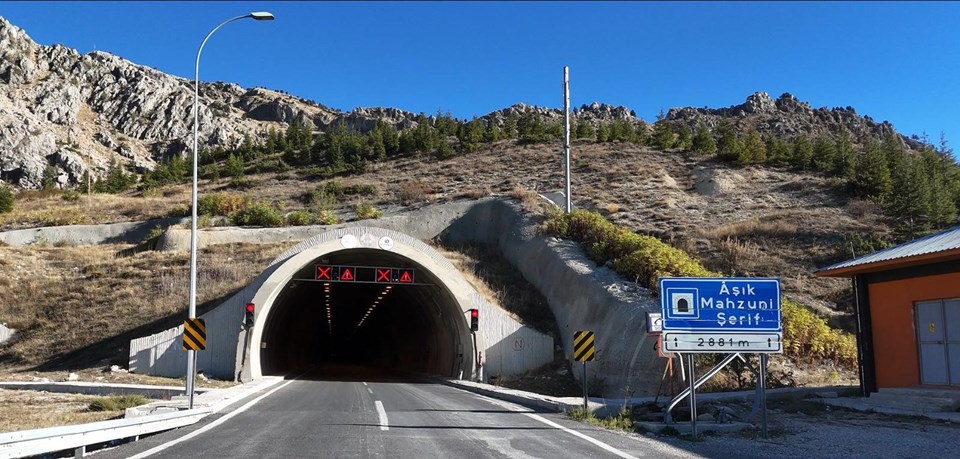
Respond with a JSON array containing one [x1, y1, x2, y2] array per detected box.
[[816, 226, 960, 395]]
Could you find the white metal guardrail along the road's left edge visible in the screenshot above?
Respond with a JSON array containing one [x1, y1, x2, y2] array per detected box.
[[0, 408, 213, 459]]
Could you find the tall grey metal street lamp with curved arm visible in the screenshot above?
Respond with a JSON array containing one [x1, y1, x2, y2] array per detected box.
[[186, 11, 274, 409]]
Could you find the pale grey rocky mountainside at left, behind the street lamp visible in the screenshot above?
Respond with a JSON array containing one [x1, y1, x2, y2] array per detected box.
[[0, 17, 415, 188]]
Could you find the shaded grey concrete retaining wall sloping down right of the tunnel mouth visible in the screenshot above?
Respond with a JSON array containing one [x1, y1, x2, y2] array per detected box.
[[441, 201, 664, 398]]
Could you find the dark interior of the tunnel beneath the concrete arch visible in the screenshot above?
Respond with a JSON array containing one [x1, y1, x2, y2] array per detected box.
[[257, 249, 472, 376]]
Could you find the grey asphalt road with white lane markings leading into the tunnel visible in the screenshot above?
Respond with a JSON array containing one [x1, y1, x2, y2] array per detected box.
[[94, 367, 692, 459]]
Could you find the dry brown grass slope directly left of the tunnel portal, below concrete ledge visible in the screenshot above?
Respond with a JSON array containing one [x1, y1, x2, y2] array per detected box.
[[0, 244, 285, 367]]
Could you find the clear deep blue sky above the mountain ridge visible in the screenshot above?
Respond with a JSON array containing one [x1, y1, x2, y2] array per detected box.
[[0, 1, 960, 149]]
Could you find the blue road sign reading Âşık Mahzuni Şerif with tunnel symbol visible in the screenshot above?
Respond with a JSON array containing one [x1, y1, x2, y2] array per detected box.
[[660, 277, 783, 333]]
